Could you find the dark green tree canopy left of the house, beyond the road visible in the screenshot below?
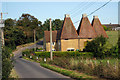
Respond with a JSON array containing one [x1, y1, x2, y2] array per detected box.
[[4, 14, 63, 49]]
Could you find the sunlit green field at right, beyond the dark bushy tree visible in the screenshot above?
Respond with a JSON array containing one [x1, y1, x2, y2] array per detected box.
[[106, 31, 118, 46]]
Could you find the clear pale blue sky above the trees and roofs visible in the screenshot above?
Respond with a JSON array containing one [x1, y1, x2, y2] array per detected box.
[[0, 0, 118, 29]]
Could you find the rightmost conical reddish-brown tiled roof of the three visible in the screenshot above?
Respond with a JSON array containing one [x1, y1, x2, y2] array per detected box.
[[92, 18, 108, 38]]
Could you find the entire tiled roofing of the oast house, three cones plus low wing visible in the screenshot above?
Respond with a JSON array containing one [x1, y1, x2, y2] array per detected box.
[[44, 15, 108, 42]]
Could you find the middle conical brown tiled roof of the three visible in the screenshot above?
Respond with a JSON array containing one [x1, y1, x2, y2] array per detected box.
[[77, 16, 97, 39]]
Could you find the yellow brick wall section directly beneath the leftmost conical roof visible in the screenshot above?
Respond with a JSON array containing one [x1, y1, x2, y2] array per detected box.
[[61, 39, 79, 51]]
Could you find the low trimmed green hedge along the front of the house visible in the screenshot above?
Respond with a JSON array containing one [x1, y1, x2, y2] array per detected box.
[[35, 51, 93, 58]]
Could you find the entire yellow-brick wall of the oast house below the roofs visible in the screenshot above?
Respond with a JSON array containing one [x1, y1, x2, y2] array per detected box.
[[45, 39, 92, 51]]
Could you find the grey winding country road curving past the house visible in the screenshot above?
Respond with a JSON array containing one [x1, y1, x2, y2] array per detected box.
[[13, 42, 71, 80]]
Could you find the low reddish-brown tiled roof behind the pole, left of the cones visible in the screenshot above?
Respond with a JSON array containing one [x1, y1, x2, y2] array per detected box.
[[44, 31, 58, 42]]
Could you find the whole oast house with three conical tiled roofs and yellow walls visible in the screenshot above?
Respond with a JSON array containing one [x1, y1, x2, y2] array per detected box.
[[44, 14, 108, 51]]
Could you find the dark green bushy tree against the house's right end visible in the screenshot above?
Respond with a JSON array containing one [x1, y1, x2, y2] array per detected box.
[[84, 36, 107, 58]]
